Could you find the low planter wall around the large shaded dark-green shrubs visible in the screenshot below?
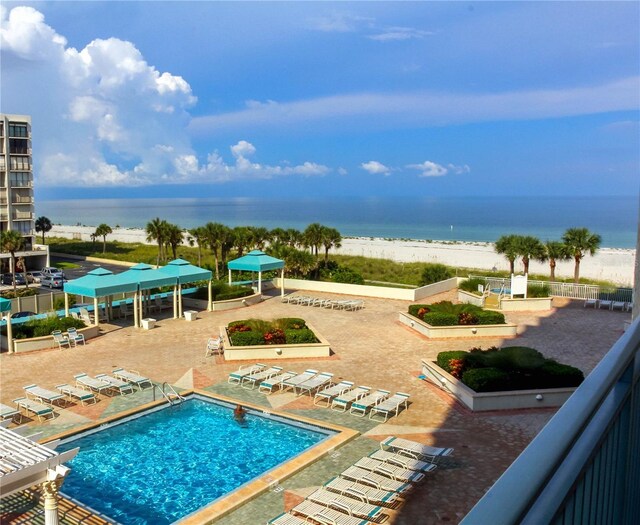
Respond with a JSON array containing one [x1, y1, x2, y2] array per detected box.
[[422, 359, 576, 412]]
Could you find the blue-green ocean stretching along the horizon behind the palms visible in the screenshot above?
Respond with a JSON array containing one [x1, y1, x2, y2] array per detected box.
[[36, 197, 638, 248]]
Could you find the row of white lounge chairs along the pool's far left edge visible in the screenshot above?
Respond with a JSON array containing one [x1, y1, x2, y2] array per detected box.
[[0, 368, 153, 424]]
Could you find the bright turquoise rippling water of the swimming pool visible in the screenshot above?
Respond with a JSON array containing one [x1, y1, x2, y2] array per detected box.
[[58, 399, 332, 525]]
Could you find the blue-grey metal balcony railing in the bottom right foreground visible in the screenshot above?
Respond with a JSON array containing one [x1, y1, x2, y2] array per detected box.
[[461, 317, 640, 525]]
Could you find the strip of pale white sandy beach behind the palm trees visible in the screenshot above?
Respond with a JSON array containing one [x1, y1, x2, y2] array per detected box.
[[49, 225, 636, 286]]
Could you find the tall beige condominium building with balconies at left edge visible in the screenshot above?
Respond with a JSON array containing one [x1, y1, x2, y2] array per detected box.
[[0, 113, 48, 272]]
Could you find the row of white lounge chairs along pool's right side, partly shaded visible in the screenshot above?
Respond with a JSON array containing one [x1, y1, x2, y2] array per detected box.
[[268, 437, 453, 525]]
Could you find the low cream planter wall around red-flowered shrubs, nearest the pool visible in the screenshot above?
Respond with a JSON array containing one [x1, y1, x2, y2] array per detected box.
[[220, 323, 331, 361]]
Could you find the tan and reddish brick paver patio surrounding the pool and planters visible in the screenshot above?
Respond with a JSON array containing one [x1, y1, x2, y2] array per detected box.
[[0, 293, 629, 525]]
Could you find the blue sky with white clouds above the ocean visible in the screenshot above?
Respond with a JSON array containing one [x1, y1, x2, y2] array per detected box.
[[0, 1, 640, 200]]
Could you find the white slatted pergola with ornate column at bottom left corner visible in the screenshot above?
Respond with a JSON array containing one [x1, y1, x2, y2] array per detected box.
[[0, 426, 80, 525]]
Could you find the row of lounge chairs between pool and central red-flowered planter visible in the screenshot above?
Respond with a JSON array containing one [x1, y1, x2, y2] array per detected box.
[[227, 363, 410, 422]]
